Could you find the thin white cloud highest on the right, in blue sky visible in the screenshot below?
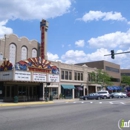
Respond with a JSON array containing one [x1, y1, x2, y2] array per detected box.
[[79, 11, 129, 23]]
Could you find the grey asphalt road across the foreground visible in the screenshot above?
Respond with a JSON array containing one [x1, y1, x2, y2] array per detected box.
[[0, 99, 130, 130]]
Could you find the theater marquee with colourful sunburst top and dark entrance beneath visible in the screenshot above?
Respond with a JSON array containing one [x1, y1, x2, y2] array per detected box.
[[0, 57, 59, 102]]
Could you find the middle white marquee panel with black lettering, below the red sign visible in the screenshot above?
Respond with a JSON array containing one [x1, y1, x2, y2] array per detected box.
[[33, 73, 46, 82]]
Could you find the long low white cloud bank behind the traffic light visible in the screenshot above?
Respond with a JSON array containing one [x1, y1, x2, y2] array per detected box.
[[61, 48, 130, 69]]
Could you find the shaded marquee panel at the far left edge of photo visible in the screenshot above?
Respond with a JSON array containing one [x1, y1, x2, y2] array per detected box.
[[0, 71, 13, 81]]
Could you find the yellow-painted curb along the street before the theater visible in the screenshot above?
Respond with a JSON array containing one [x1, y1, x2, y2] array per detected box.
[[0, 101, 54, 107]]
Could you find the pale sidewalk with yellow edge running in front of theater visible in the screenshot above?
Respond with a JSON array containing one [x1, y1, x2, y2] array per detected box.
[[0, 99, 79, 107]]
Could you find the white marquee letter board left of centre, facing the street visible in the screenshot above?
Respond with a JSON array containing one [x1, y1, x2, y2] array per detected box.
[[14, 71, 31, 81]]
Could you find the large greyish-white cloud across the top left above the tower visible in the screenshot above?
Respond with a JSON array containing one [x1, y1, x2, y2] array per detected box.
[[0, 0, 71, 21]]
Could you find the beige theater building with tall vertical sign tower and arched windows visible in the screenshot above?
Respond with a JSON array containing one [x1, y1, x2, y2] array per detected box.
[[0, 20, 101, 101]]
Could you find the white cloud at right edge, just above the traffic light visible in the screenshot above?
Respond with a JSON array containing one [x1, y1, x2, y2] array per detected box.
[[88, 30, 130, 48]]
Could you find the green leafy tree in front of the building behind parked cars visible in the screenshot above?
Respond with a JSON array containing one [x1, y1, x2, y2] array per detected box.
[[90, 69, 112, 87]]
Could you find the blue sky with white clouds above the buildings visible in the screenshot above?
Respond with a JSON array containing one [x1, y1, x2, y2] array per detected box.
[[0, 0, 130, 69]]
